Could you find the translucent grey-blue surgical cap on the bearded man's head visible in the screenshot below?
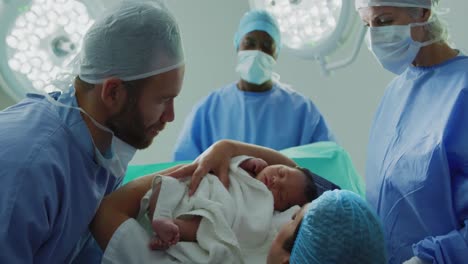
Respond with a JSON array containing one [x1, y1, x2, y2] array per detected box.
[[79, 1, 184, 84]]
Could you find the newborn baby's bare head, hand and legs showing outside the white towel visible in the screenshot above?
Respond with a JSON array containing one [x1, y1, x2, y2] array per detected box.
[[148, 158, 317, 249]]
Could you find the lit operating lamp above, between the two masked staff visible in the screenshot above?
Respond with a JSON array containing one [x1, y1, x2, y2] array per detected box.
[[249, 0, 366, 74]]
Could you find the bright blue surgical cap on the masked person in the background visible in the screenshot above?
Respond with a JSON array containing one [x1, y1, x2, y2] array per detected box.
[[234, 10, 281, 54]]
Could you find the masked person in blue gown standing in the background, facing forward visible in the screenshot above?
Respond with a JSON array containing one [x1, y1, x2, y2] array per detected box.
[[173, 10, 334, 160]]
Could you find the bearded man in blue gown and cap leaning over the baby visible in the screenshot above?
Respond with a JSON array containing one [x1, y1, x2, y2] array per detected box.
[[0, 1, 184, 263]]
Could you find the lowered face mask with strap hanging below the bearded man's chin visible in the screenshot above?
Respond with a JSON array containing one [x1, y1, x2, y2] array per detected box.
[[45, 89, 136, 178]]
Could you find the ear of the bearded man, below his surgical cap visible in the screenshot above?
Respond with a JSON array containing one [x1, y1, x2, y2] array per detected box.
[[101, 78, 127, 113]]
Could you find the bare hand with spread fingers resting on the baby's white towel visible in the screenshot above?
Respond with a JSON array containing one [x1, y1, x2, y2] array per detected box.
[[169, 141, 235, 195]]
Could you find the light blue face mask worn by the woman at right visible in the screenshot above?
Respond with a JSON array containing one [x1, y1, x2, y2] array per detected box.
[[367, 19, 440, 74]]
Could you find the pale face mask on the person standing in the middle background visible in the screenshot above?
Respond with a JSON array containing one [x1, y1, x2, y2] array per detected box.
[[236, 50, 276, 85]]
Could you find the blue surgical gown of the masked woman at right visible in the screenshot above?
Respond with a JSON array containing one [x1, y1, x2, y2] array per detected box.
[[366, 56, 468, 263]]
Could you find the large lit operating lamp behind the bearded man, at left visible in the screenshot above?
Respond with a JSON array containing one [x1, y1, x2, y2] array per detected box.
[[0, 0, 102, 100]]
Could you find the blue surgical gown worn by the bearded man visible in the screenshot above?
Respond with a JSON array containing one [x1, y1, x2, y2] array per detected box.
[[0, 90, 121, 263]]
